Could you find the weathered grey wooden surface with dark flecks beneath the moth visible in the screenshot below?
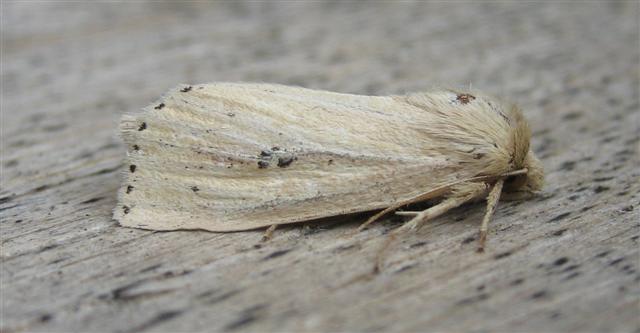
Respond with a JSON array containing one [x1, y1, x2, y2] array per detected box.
[[0, 1, 640, 332]]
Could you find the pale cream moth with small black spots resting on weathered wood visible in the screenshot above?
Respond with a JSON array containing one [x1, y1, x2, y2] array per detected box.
[[114, 83, 544, 248]]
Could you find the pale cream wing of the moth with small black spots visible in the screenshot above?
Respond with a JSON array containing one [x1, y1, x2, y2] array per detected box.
[[114, 83, 478, 232]]
